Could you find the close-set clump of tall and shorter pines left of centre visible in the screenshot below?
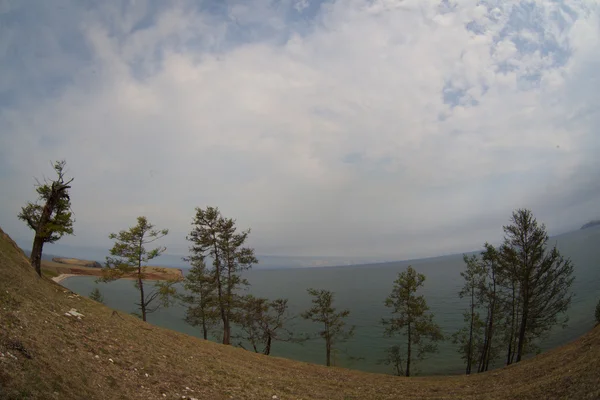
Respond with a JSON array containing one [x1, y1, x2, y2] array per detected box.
[[187, 207, 258, 344]]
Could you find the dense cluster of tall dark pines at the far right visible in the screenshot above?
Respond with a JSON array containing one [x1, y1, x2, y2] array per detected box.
[[453, 209, 574, 374]]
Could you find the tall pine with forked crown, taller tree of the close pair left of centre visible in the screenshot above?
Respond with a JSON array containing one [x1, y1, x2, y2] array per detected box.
[[187, 207, 258, 344]]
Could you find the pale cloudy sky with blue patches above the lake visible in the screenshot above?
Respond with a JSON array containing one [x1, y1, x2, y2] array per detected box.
[[0, 0, 600, 260]]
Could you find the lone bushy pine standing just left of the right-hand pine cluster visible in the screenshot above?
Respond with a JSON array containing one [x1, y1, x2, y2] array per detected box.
[[381, 266, 444, 376]]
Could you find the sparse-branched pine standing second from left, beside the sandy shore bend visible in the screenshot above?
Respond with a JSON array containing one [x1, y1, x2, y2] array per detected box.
[[99, 217, 176, 321]]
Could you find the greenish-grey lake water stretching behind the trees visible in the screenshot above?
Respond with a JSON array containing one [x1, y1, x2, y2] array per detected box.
[[63, 228, 600, 375]]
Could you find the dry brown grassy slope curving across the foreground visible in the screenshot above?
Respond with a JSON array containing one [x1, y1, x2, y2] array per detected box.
[[0, 230, 600, 400]]
